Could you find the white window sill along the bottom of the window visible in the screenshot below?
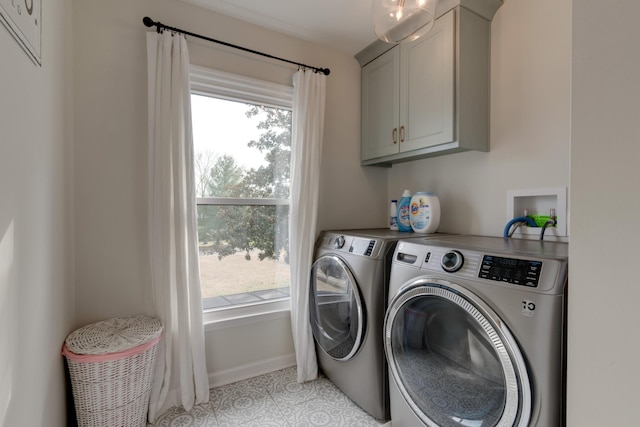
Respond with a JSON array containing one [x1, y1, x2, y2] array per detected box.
[[203, 298, 291, 332]]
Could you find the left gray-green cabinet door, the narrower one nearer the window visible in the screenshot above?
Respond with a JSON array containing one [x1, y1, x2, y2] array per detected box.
[[361, 46, 400, 160]]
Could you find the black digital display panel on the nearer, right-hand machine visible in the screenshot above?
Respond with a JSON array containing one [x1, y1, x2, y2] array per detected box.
[[478, 255, 542, 288]]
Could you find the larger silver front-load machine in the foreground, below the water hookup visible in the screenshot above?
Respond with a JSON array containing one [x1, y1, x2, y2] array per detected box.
[[384, 236, 568, 427]]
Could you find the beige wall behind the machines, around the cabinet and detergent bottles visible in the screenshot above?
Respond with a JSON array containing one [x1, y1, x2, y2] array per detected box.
[[388, 0, 571, 236]]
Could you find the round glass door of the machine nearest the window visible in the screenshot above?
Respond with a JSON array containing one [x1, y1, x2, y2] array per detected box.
[[309, 255, 365, 360]]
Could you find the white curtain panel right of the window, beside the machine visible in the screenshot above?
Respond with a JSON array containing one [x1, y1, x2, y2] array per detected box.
[[289, 70, 326, 382]]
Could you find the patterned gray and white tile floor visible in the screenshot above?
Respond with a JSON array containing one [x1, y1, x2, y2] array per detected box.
[[147, 367, 390, 427]]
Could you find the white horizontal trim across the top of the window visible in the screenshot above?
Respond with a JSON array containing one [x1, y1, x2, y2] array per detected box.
[[190, 65, 293, 110]]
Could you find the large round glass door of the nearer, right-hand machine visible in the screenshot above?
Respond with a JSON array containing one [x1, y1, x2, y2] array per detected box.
[[384, 278, 531, 427]]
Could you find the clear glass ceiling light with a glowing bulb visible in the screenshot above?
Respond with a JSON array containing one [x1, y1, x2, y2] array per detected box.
[[373, 0, 437, 43]]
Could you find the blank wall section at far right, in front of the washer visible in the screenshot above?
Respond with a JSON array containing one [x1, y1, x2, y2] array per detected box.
[[568, 0, 640, 427]]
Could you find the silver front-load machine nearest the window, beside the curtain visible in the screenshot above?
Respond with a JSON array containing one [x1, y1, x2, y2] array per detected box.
[[309, 229, 415, 420]]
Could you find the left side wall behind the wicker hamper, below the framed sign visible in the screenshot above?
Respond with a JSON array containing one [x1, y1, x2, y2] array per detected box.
[[0, 0, 75, 427]]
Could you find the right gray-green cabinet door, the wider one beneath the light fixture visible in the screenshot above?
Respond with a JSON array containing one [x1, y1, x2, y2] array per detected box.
[[399, 10, 456, 152]]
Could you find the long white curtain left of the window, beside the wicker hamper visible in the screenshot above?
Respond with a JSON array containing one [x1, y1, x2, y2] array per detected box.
[[147, 32, 209, 422]]
